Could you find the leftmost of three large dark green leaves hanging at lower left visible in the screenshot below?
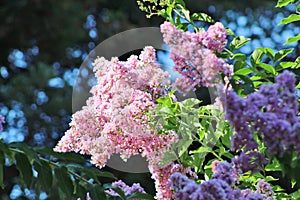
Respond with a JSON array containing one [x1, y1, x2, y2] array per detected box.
[[15, 153, 33, 187]]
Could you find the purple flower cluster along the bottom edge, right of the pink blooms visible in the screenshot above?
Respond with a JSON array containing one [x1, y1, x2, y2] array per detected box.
[[169, 161, 274, 200]]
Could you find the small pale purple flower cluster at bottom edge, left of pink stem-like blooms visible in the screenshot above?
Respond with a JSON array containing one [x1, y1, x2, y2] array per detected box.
[[105, 180, 146, 196]]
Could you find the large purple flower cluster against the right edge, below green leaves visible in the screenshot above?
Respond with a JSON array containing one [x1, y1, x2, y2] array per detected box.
[[225, 71, 300, 157]]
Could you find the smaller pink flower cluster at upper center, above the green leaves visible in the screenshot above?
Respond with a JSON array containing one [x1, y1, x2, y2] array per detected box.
[[160, 22, 233, 93]]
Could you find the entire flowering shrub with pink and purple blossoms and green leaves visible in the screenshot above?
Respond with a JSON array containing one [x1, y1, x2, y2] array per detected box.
[[0, 0, 300, 200]]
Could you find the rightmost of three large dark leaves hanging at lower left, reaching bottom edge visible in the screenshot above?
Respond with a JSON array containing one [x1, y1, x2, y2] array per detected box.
[[55, 167, 74, 199]]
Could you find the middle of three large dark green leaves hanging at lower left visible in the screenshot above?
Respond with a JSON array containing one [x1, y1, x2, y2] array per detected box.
[[34, 160, 53, 193]]
